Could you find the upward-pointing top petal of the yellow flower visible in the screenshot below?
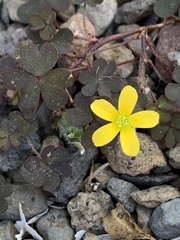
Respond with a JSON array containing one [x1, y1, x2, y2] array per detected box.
[[118, 85, 138, 115]]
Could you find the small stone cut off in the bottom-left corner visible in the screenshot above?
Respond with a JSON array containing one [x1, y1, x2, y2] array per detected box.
[[0, 220, 17, 240]]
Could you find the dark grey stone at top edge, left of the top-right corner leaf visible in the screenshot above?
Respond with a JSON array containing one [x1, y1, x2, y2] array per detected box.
[[115, 0, 157, 24]]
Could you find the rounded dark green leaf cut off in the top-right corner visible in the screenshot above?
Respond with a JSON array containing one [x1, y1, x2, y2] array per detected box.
[[154, 0, 180, 18]]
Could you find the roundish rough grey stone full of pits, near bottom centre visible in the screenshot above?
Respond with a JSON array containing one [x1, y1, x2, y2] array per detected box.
[[67, 190, 114, 234]]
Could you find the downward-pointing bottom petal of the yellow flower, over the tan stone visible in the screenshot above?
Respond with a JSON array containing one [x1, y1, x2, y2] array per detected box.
[[120, 127, 140, 157]]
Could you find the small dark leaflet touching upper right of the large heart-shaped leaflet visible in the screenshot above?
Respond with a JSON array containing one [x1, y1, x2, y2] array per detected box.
[[51, 28, 73, 54]]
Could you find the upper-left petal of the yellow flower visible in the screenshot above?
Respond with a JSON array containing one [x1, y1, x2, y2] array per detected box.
[[90, 99, 119, 121]]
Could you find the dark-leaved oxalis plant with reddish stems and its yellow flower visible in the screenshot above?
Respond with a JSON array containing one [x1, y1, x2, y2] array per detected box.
[[0, 0, 180, 211]]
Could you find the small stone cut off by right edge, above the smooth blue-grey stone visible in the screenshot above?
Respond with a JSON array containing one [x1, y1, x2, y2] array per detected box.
[[166, 146, 180, 169]]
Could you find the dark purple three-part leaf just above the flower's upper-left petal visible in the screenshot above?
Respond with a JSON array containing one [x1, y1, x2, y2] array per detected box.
[[79, 58, 123, 97]]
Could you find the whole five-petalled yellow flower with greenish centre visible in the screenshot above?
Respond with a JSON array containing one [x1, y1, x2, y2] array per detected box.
[[91, 85, 159, 156]]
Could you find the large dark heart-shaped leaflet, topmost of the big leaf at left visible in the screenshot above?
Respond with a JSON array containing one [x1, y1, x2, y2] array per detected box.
[[14, 41, 58, 76]]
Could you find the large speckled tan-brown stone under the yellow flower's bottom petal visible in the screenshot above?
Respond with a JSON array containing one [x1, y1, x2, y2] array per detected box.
[[101, 133, 167, 176]]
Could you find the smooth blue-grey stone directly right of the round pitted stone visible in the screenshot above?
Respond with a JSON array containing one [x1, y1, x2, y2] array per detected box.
[[107, 178, 138, 213]]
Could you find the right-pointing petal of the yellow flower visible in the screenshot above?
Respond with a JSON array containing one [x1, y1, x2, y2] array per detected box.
[[129, 110, 159, 128]]
